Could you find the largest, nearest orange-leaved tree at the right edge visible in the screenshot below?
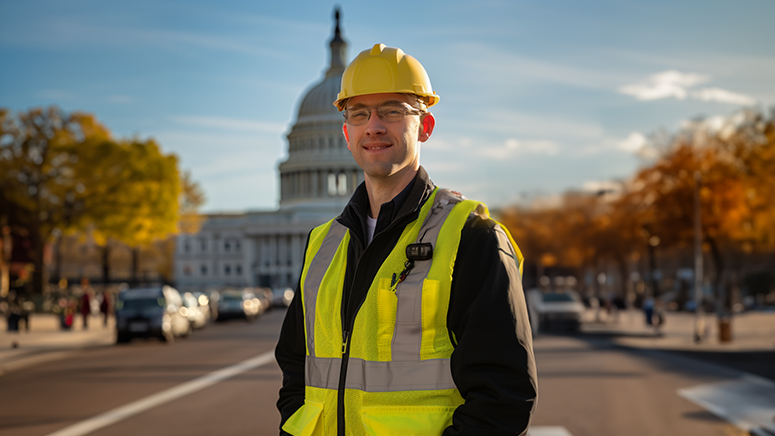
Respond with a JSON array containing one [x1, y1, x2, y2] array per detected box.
[[627, 111, 775, 304]]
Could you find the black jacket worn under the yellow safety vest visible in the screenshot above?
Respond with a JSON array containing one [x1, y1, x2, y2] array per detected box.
[[275, 167, 537, 436]]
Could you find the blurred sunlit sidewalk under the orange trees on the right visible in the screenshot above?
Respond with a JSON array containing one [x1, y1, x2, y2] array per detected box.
[[582, 310, 775, 352]]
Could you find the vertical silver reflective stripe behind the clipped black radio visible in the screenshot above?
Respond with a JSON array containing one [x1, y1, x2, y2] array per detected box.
[[391, 189, 461, 361]]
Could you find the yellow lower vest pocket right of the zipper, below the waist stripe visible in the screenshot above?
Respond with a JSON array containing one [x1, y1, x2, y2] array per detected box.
[[361, 406, 456, 436]]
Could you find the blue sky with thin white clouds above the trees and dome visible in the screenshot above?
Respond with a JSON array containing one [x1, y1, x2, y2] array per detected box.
[[0, 0, 775, 212]]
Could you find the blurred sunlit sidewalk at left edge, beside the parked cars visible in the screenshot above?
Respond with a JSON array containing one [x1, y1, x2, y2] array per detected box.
[[0, 314, 115, 376]]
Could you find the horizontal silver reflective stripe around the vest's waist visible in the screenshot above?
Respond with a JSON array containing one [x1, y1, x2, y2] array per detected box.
[[305, 350, 456, 392]]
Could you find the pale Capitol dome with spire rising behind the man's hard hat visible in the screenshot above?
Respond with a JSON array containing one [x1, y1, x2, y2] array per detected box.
[[279, 10, 363, 209]]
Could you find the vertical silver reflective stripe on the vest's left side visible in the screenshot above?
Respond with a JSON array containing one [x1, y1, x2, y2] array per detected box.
[[304, 220, 347, 356]]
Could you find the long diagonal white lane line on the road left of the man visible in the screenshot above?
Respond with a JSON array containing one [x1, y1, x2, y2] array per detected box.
[[47, 351, 274, 436]]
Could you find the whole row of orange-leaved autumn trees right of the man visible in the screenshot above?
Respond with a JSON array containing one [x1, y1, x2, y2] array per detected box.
[[502, 110, 775, 306]]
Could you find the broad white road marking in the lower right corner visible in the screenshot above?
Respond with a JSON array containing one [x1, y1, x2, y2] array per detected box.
[[678, 375, 775, 431]]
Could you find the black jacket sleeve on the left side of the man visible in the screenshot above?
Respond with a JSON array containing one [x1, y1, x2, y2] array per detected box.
[[275, 236, 309, 435]]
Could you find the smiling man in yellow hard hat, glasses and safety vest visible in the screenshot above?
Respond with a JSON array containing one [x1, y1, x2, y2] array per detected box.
[[276, 44, 537, 436]]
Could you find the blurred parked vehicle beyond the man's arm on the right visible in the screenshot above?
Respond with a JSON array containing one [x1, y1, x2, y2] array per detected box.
[[528, 290, 584, 332]]
